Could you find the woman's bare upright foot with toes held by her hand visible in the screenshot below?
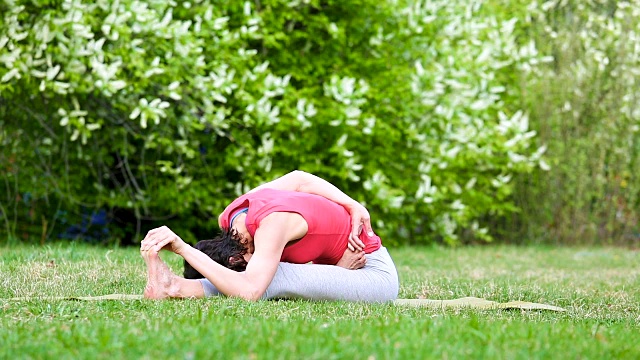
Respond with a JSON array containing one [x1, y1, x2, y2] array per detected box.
[[140, 250, 178, 299]]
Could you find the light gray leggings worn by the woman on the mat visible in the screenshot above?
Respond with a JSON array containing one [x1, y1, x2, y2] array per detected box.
[[200, 247, 398, 302]]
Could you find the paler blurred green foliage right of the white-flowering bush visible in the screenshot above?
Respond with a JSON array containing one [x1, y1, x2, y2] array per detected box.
[[509, 1, 640, 245]]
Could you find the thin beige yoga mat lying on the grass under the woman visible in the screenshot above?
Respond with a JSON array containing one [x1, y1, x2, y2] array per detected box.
[[0, 294, 566, 311]]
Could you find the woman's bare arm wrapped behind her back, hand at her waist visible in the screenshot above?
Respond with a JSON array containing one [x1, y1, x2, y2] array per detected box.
[[251, 170, 373, 250]]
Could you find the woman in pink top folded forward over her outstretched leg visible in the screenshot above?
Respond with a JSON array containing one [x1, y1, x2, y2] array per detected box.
[[141, 171, 398, 302]]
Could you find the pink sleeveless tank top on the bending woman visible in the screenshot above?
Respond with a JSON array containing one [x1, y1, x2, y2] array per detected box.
[[220, 189, 381, 265]]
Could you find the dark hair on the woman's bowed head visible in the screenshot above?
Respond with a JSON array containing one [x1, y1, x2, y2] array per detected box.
[[184, 229, 248, 279]]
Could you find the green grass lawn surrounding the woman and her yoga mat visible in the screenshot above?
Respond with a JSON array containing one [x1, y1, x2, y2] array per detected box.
[[0, 244, 640, 359]]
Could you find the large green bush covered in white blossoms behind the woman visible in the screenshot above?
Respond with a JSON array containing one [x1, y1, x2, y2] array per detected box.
[[0, 0, 552, 245]]
